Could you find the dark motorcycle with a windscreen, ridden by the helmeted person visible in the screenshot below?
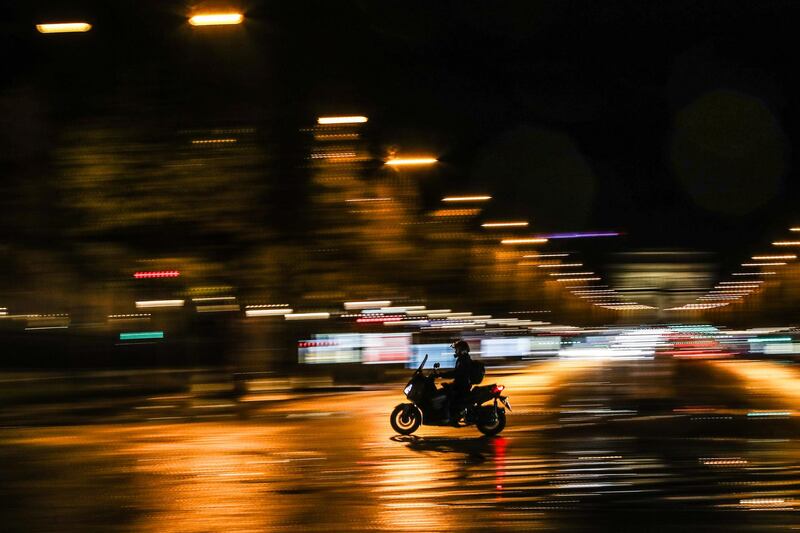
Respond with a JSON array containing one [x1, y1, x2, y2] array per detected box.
[[389, 354, 511, 436]]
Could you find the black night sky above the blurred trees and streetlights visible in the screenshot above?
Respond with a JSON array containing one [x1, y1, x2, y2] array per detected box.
[[0, 0, 800, 274]]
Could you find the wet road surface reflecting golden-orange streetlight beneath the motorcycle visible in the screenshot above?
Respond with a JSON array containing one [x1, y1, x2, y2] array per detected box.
[[0, 360, 800, 532]]
